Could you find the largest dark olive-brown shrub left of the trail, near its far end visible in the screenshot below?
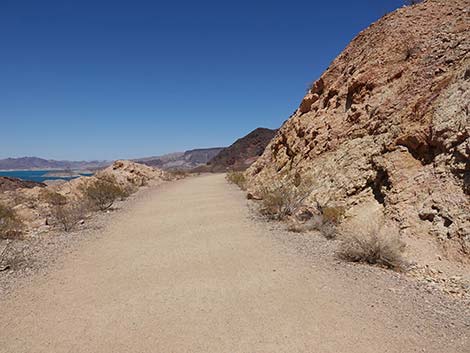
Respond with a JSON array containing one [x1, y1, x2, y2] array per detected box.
[[80, 177, 128, 211]]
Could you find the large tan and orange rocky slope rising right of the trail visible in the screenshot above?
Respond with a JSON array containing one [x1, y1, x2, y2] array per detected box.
[[247, 0, 470, 262]]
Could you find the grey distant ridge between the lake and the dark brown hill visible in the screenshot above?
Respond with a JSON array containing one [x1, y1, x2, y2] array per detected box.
[[134, 147, 224, 170]]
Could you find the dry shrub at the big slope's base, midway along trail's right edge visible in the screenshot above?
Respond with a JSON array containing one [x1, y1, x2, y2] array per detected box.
[[260, 176, 312, 220]]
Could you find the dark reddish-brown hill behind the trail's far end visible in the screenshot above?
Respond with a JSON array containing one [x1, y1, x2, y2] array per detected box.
[[206, 128, 276, 172]]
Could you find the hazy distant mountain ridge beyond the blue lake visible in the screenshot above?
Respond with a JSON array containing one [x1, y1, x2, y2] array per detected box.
[[0, 157, 111, 170]]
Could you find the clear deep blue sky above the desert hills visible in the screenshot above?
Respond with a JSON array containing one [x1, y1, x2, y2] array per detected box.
[[0, 0, 402, 159]]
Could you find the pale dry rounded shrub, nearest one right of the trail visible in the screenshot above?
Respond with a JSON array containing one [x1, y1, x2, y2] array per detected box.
[[338, 220, 405, 270]]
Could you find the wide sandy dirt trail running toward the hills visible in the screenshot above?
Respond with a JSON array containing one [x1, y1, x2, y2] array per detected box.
[[0, 175, 470, 353]]
